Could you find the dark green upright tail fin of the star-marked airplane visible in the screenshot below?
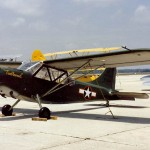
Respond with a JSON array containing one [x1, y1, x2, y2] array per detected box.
[[91, 68, 116, 90]]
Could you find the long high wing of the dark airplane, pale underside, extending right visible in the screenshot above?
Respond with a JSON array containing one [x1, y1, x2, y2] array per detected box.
[[44, 49, 150, 70]]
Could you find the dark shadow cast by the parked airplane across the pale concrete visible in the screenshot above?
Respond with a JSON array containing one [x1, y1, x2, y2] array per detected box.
[[0, 104, 150, 124]]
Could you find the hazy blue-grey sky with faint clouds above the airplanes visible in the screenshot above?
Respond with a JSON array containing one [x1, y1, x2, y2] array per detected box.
[[0, 0, 150, 59]]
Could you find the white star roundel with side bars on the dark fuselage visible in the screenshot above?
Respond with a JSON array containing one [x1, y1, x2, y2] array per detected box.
[[79, 86, 96, 100]]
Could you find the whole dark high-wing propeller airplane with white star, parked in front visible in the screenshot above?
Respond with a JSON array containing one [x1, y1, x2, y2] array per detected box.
[[0, 49, 150, 119]]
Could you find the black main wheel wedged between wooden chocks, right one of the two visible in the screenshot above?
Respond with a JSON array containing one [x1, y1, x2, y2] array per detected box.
[[39, 107, 51, 119]]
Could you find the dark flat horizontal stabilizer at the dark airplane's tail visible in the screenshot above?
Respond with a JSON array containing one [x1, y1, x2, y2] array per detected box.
[[114, 92, 149, 100]]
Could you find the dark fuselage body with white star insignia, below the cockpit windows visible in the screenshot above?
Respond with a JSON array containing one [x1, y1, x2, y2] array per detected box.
[[0, 65, 112, 103]]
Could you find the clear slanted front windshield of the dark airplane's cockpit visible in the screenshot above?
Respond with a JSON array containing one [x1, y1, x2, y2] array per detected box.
[[18, 62, 42, 74]]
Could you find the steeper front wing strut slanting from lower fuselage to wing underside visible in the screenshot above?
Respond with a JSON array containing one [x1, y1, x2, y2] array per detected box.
[[41, 59, 92, 97]]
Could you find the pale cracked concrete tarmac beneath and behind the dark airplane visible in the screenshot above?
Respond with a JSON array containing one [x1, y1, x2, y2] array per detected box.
[[0, 75, 150, 150]]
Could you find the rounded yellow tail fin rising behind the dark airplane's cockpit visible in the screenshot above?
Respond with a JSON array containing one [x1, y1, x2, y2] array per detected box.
[[32, 49, 46, 61]]
